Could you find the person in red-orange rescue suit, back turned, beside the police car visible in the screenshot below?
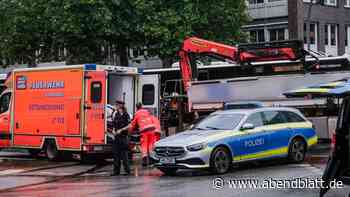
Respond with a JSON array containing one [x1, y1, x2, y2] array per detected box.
[[129, 103, 156, 166]]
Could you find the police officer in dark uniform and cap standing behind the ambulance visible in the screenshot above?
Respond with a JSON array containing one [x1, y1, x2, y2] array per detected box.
[[111, 101, 130, 176]]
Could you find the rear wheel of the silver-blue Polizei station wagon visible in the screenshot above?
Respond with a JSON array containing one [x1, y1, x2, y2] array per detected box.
[[289, 138, 306, 163]]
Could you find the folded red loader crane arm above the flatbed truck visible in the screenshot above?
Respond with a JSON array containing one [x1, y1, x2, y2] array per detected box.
[[179, 37, 305, 91]]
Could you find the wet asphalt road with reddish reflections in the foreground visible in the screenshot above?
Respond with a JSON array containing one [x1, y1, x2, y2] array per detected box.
[[0, 145, 350, 197]]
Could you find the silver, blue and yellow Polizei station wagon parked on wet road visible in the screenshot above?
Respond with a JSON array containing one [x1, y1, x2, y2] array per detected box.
[[151, 107, 317, 174]]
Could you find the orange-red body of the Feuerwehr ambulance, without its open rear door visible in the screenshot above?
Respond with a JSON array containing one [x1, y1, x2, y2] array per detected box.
[[0, 65, 142, 160]]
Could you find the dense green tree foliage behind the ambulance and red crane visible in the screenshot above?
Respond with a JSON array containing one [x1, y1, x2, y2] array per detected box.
[[0, 0, 248, 67]]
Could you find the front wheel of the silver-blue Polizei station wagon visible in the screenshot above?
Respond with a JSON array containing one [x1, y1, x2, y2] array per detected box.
[[210, 147, 231, 174]]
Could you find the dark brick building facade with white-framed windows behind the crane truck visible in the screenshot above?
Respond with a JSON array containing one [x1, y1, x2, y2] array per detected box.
[[243, 0, 350, 56]]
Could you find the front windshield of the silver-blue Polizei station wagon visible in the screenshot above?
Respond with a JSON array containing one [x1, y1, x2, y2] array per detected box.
[[193, 113, 244, 130]]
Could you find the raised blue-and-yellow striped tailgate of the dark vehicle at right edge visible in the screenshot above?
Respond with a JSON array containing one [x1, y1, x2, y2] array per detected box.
[[283, 78, 350, 98]]
